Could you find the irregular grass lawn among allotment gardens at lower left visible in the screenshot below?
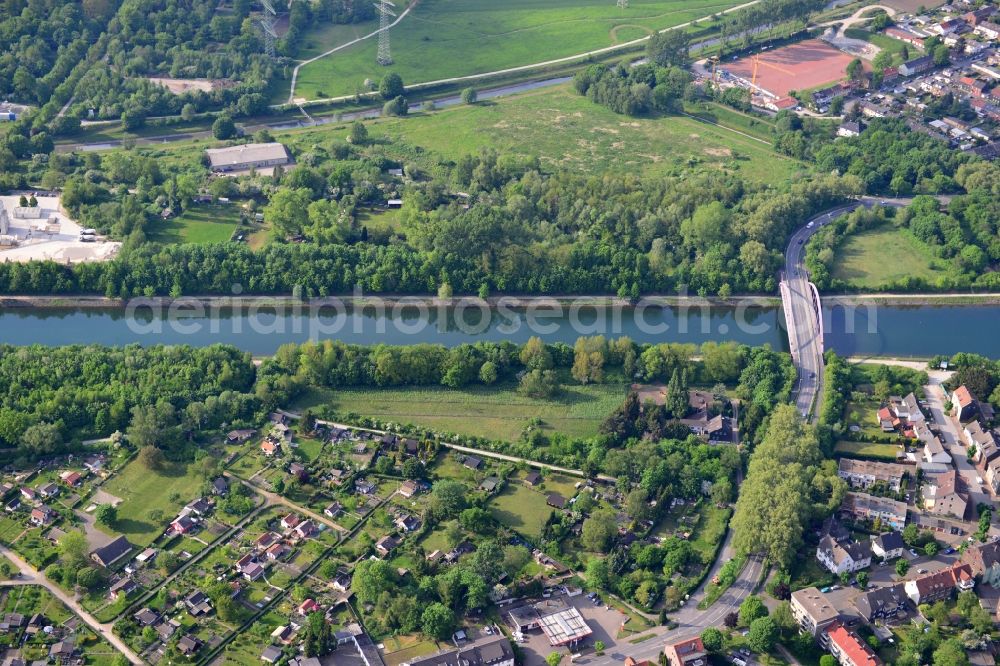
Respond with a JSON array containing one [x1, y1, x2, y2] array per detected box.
[[104, 460, 202, 546]]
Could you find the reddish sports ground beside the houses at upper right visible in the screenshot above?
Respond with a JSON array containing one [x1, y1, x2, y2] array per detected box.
[[725, 39, 853, 97]]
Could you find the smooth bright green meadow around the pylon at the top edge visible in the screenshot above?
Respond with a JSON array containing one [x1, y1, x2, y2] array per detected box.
[[295, 0, 739, 99]]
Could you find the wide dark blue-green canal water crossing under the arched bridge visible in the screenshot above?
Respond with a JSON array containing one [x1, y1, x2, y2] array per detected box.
[[0, 305, 1000, 358]]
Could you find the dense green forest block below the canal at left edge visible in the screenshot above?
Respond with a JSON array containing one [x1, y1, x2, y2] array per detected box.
[[0, 345, 258, 456]]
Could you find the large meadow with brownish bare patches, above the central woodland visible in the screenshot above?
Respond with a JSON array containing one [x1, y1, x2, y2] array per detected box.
[[370, 85, 805, 183]]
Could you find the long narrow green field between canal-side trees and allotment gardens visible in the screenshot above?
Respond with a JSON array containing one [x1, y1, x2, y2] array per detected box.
[[294, 384, 625, 441]]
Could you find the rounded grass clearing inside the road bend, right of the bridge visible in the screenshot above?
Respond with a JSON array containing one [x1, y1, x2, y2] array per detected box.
[[833, 227, 945, 289]]
